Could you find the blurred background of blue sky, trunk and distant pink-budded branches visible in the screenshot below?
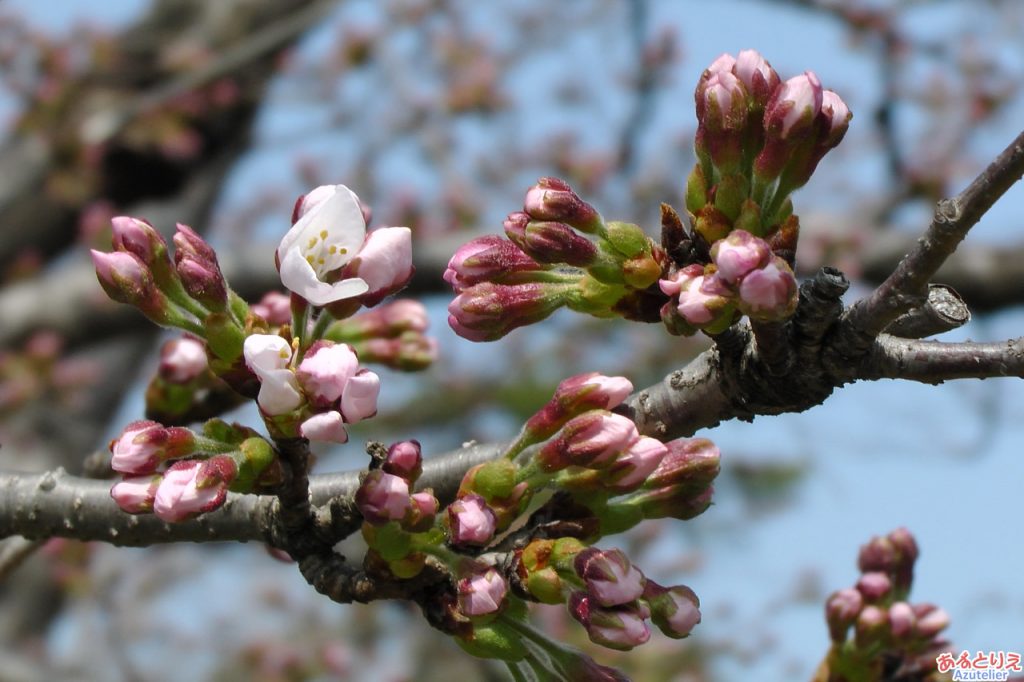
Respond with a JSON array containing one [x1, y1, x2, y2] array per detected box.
[[0, 0, 1024, 681]]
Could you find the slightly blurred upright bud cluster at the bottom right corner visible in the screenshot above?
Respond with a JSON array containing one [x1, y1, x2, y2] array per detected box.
[[822, 528, 949, 680]]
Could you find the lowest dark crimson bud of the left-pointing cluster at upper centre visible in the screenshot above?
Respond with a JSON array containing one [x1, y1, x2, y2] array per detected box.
[[449, 282, 566, 341]]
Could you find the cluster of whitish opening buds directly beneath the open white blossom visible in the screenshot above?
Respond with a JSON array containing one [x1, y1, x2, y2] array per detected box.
[[243, 334, 380, 442]]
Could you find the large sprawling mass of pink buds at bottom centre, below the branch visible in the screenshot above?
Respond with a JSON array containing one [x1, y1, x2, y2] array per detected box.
[[348, 373, 719, 657]]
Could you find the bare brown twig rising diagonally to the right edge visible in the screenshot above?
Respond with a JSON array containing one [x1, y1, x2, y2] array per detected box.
[[846, 125, 1024, 338]]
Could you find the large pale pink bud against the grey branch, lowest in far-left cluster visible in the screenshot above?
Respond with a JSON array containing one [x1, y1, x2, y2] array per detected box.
[[153, 457, 236, 523]]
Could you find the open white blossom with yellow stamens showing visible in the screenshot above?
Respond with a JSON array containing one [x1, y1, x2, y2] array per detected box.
[[278, 184, 370, 306]]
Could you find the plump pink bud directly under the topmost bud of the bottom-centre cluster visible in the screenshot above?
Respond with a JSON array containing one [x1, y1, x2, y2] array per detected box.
[[537, 410, 640, 471]]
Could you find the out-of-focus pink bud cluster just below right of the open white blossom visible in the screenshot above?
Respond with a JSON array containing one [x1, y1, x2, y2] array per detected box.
[[324, 298, 437, 372]]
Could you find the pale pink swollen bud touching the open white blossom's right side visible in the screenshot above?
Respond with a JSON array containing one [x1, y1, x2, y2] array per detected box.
[[342, 227, 415, 307]]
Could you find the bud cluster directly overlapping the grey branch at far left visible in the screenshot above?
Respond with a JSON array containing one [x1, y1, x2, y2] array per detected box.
[[110, 413, 280, 522]]
